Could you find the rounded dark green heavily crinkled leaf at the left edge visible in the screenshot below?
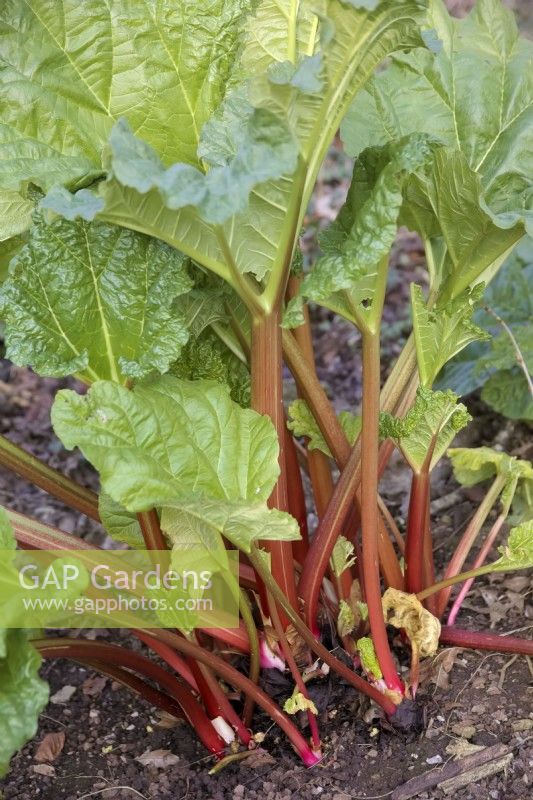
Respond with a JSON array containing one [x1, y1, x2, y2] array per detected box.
[[0, 214, 191, 382]]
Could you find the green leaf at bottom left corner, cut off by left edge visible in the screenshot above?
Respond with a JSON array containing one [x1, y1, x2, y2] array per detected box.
[[0, 629, 48, 777]]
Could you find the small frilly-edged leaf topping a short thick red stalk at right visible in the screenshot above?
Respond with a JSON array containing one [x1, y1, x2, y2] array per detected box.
[[380, 387, 472, 472]]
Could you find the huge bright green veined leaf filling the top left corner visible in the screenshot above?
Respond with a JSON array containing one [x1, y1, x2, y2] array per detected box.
[[0, 0, 250, 231]]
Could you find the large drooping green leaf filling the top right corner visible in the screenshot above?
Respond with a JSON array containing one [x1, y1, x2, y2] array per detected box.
[[342, 0, 533, 298]]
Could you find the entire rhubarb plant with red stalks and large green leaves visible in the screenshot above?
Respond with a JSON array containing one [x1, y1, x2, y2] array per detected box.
[[0, 0, 533, 768]]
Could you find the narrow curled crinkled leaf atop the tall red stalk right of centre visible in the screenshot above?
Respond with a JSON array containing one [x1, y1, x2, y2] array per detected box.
[[283, 135, 432, 327]]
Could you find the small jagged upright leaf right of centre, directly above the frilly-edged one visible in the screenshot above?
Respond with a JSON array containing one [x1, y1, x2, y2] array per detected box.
[[411, 283, 490, 387]]
